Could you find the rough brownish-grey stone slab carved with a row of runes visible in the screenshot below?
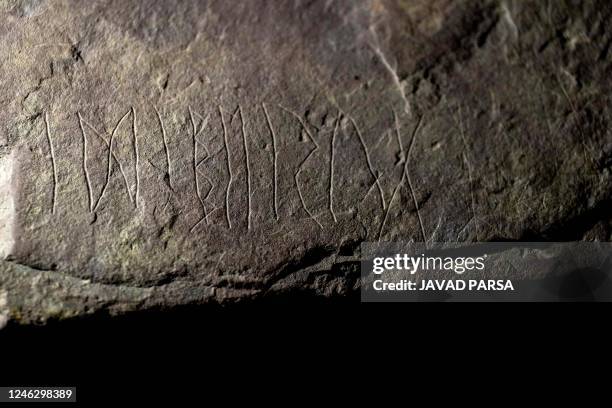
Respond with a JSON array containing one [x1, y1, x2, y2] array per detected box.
[[0, 0, 612, 323]]
